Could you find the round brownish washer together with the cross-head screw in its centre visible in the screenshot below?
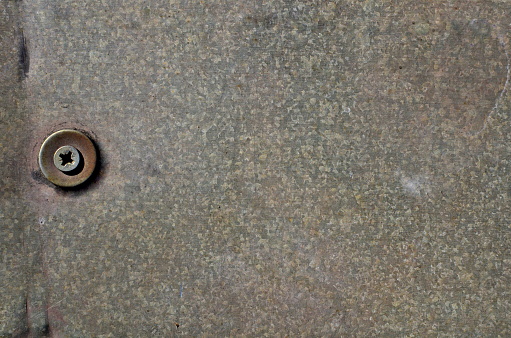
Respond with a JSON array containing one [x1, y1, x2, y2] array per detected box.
[[39, 129, 97, 187]]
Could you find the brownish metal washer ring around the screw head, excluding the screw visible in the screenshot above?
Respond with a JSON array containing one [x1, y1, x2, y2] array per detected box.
[[39, 129, 97, 187]]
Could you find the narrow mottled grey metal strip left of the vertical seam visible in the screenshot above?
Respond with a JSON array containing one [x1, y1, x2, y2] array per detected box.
[[0, 1, 31, 335]]
